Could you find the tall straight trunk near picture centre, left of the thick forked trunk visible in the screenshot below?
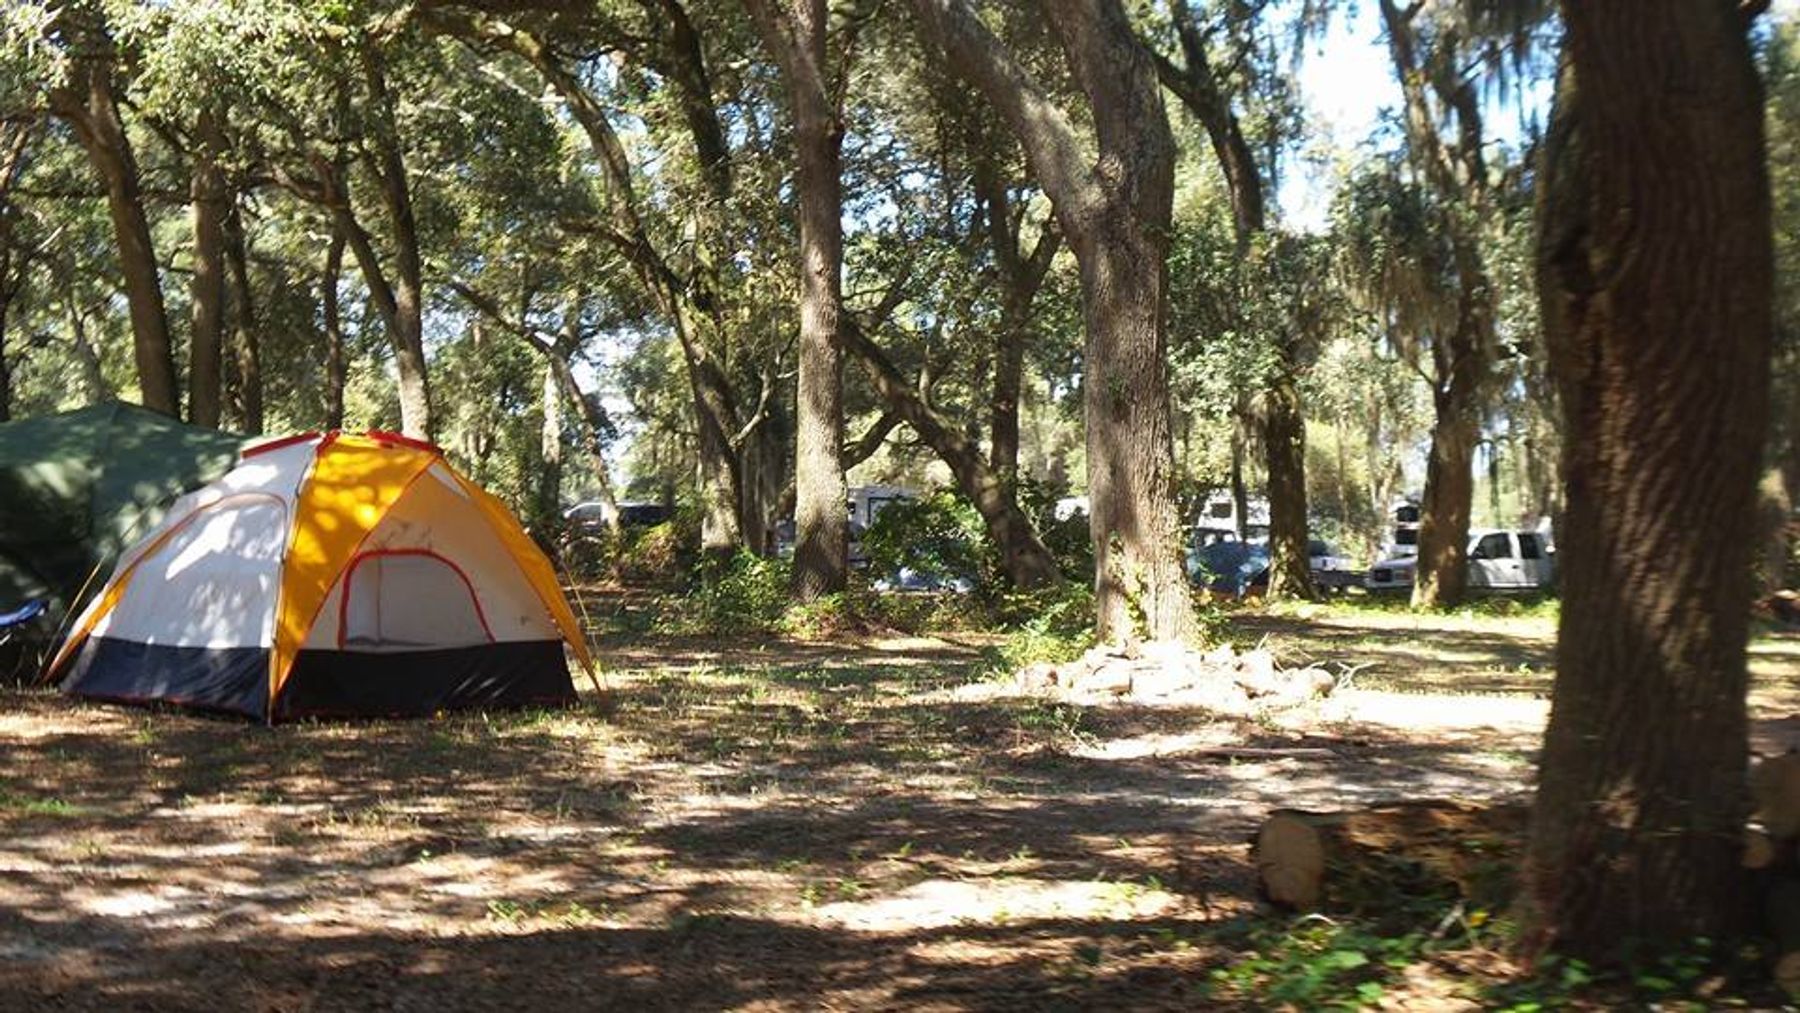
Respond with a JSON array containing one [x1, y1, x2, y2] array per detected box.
[[749, 0, 850, 601]]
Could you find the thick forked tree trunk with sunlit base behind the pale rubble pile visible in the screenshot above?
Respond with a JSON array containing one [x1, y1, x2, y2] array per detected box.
[[913, 0, 1193, 641]]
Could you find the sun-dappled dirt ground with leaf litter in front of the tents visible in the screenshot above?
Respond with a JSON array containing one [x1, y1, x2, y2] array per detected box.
[[0, 614, 1800, 1011]]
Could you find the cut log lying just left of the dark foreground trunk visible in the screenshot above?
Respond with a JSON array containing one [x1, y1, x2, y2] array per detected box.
[[1255, 799, 1528, 910]]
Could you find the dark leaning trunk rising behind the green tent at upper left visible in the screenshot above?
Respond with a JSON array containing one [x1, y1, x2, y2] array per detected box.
[[50, 40, 182, 416]]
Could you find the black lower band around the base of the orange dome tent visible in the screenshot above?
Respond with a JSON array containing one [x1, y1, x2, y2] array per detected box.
[[63, 637, 576, 722]]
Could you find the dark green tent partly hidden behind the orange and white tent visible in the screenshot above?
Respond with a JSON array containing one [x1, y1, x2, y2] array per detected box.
[[0, 401, 245, 612]]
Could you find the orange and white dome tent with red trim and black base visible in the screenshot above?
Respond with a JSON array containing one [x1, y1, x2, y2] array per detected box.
[[52, 434, 592, 723]]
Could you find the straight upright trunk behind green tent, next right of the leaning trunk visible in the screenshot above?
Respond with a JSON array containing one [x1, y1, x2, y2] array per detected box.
[[187, 113, 230, 428]]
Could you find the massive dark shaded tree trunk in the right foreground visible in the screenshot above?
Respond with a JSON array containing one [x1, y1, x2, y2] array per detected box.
[[1526, 0, 1773, 959]]
